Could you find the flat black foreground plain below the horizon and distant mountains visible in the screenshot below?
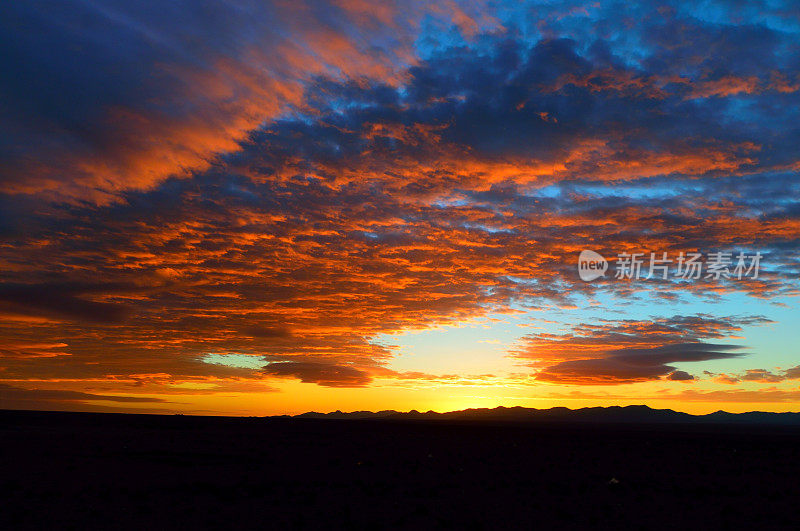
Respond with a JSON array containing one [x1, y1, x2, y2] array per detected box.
[[0, 411, 800, 529]]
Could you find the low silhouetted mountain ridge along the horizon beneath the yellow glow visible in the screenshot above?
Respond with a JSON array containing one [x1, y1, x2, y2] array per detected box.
[[284, 405, 800, 426]]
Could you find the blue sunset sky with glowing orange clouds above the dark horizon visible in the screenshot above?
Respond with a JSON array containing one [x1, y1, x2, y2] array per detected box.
[[0, 0, 800, 415]]
